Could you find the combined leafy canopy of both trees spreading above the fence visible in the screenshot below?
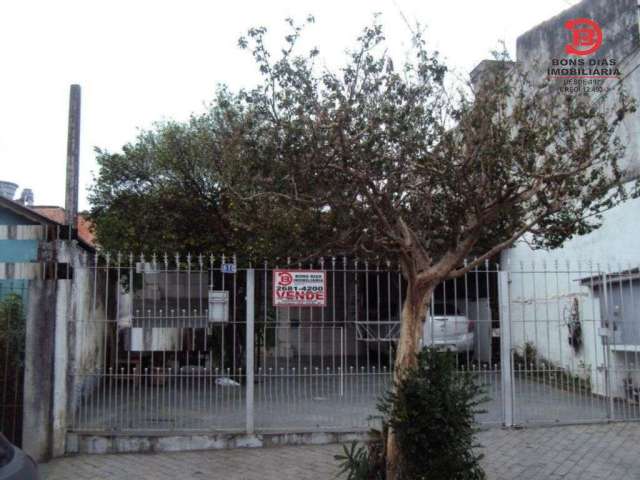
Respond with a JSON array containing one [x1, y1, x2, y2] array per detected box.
[[91, 18, 632, 268]]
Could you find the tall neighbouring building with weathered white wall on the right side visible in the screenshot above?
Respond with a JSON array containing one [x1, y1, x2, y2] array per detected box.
[[500, 0, 640, 398]]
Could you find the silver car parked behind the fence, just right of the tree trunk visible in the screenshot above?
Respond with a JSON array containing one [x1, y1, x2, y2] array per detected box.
[[422, 301, 475, 352]]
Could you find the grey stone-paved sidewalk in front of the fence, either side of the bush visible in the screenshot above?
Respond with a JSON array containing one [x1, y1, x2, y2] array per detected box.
[[41, 423, 640, 480]]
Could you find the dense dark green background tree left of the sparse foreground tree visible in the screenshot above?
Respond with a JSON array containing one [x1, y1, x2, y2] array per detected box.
[[89, 87, 338, 260]]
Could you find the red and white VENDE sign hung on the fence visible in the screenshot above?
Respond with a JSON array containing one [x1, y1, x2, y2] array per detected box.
[[273, 270, 327, 307]]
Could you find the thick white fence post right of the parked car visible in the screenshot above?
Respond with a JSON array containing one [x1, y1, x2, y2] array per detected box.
[[498, 271, 514, 427]]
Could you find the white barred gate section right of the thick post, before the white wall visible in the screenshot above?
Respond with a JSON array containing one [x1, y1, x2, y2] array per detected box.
[[500, 262, 640, 425]]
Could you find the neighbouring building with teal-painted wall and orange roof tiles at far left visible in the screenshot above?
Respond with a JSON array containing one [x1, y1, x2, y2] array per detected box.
[[0, 182, 104, 456]]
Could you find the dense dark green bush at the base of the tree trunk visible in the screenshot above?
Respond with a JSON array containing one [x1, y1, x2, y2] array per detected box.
[[378, 348, 486, 480]]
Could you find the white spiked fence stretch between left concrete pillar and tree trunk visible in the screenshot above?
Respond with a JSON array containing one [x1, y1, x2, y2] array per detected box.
[[70, 256, 403, 432]]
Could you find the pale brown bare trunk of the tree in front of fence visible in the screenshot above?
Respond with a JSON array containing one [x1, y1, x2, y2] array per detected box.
[[386, 275, 433, 480]]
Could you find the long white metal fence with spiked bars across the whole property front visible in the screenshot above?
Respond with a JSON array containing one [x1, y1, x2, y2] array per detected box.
[[70, 256, 640, 432]]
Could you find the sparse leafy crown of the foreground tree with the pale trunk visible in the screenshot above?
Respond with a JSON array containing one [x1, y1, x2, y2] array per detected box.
[[220, 18, 632, 272]]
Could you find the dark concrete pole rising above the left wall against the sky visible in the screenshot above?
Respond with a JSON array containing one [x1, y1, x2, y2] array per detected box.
[[64, 85, 80, 230]]
